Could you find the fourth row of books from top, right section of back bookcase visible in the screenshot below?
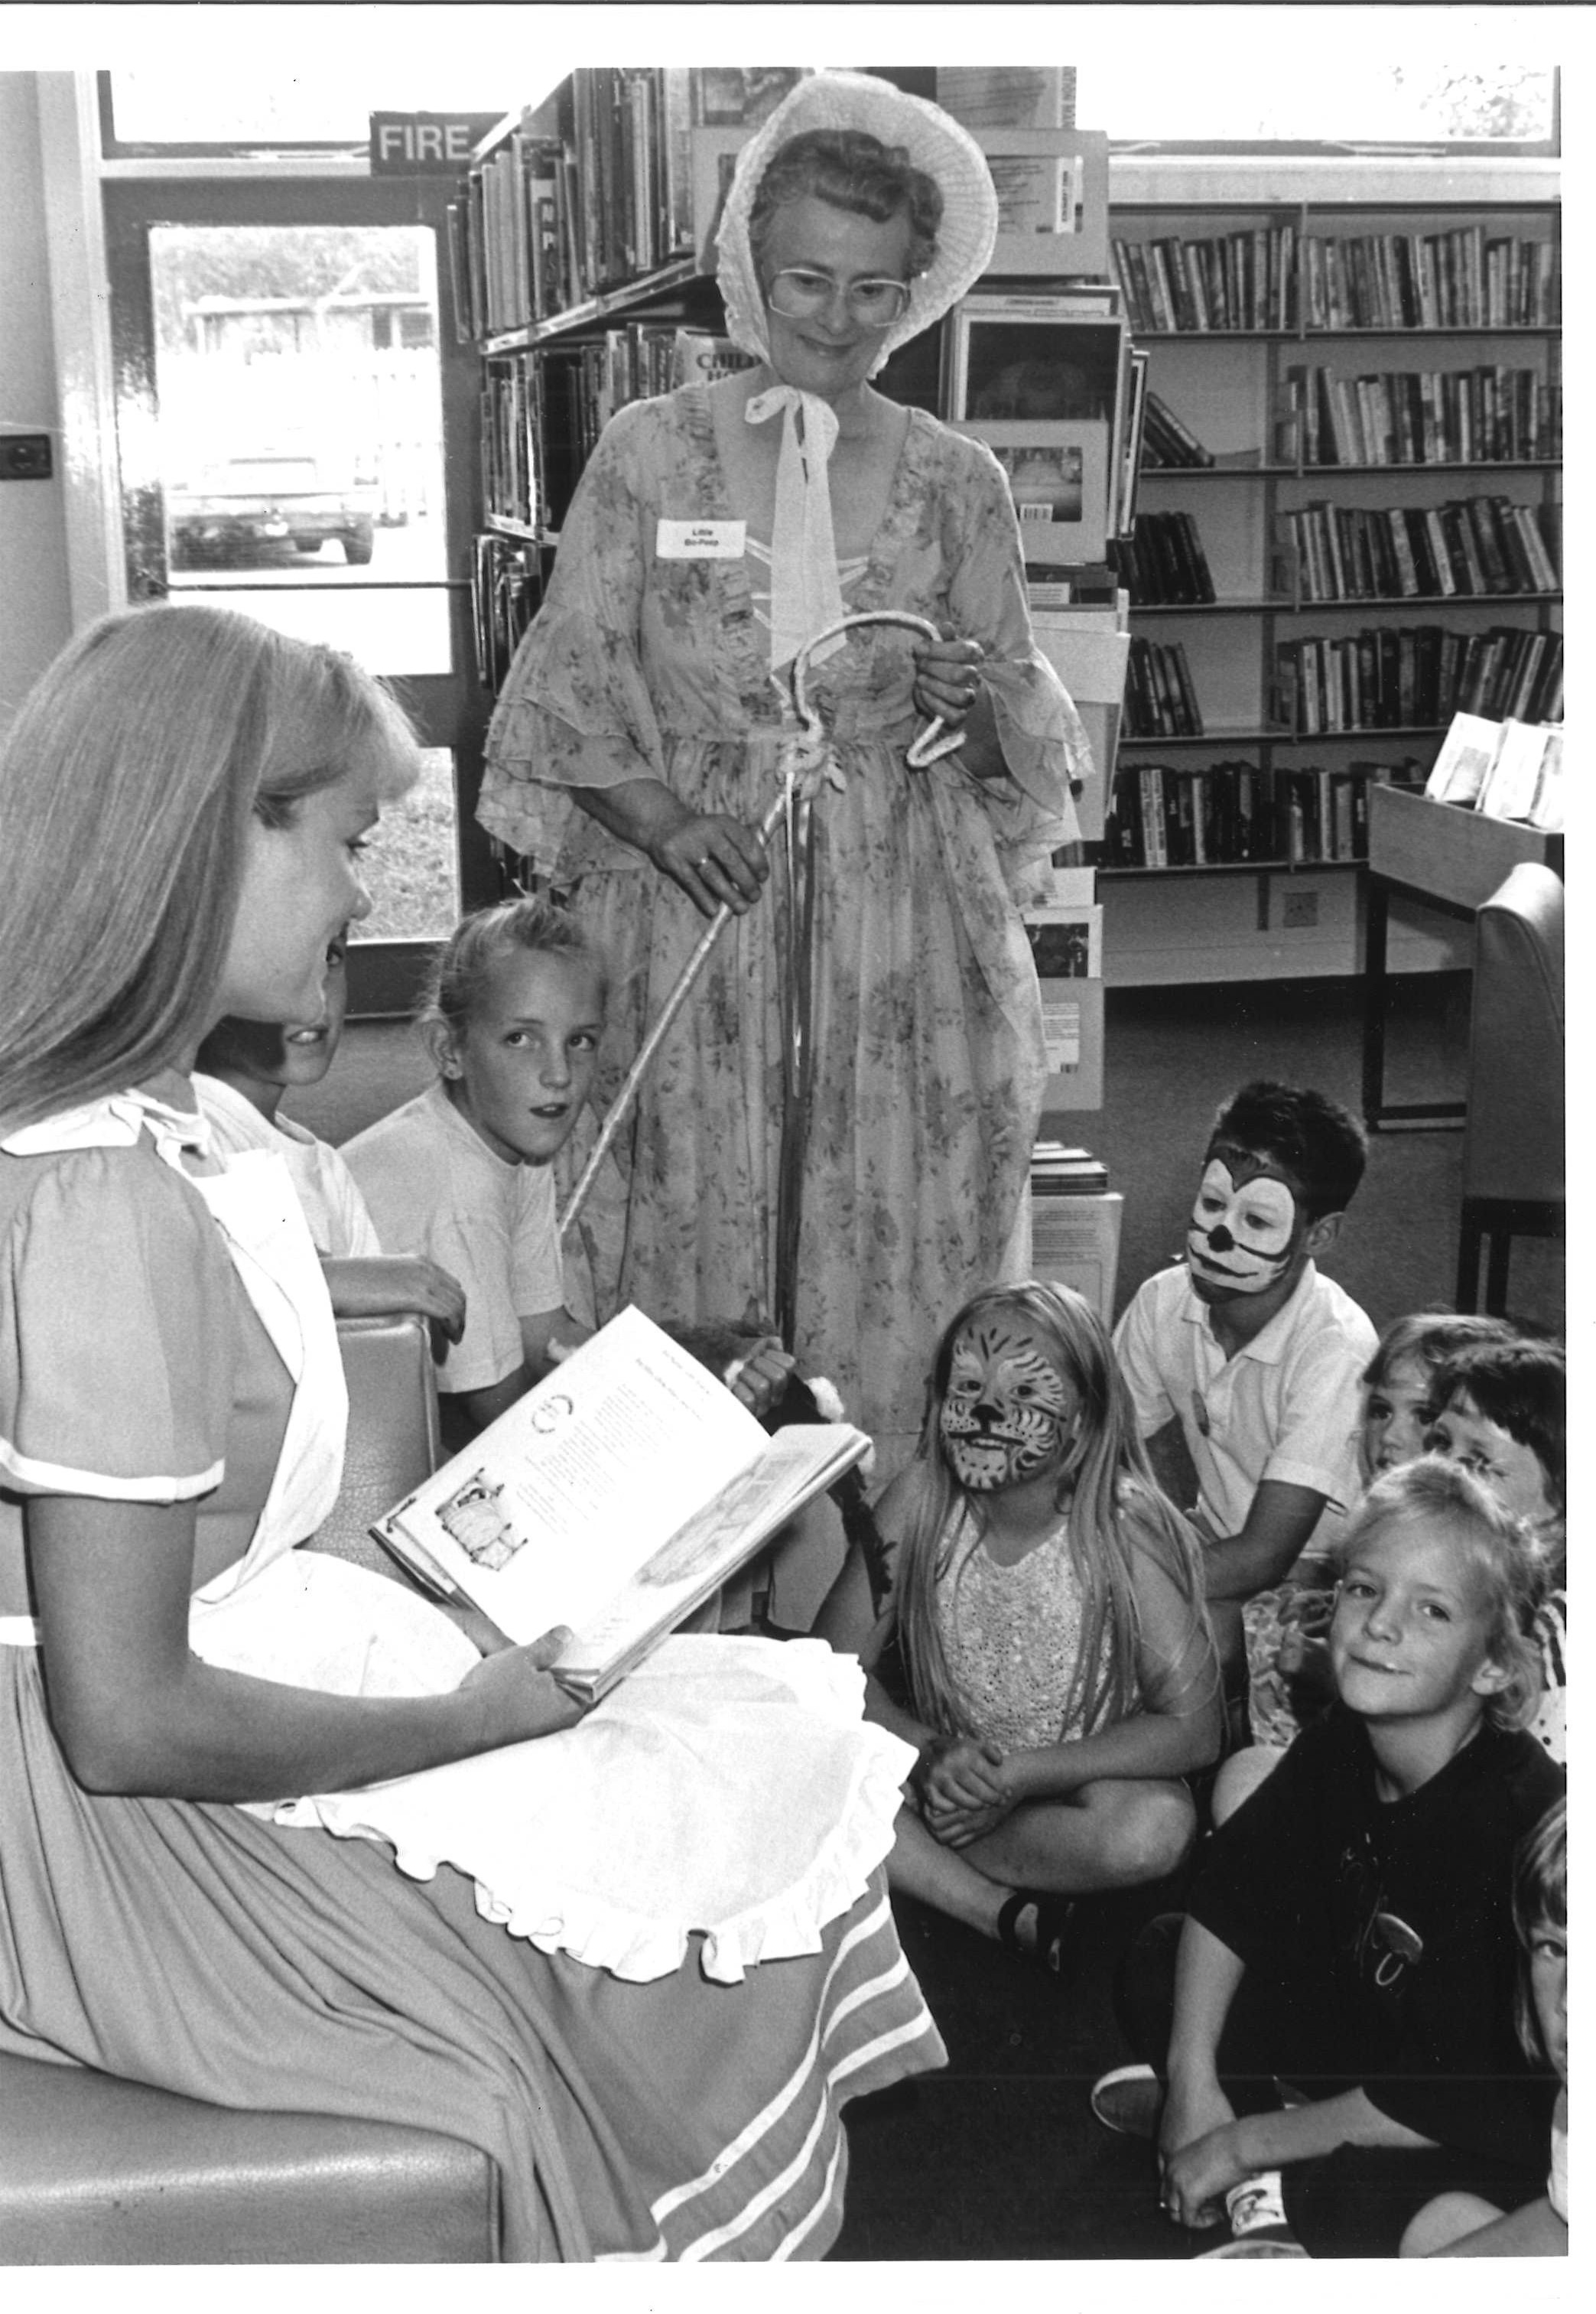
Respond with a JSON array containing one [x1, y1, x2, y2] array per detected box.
[[1275, 627, 1564, 736]]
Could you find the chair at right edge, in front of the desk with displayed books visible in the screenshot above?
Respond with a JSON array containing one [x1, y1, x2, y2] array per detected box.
[[1458, 861, 1566, 1316]]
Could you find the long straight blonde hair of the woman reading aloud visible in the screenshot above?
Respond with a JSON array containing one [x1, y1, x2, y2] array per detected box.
[[0, 604, 418, 1131]]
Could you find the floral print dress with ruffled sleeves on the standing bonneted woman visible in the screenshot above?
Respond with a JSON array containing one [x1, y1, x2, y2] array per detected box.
[[479, 382, 1090, 1472]]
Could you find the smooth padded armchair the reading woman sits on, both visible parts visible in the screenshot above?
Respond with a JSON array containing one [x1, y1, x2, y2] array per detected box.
[[0, 1316, 499, 2265]]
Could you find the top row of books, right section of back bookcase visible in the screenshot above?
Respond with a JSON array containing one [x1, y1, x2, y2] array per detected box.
[[1302, 224, 1559, 329]]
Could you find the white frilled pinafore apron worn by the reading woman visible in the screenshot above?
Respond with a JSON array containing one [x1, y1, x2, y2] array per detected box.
[[0, 1092, 914, 1983]]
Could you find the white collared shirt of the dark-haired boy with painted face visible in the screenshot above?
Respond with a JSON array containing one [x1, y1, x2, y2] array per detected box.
[[1115, 1261, 1377, 1557]]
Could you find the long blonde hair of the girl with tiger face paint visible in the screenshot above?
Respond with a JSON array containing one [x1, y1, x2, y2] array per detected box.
[[893, 1280, 1203, 1736]]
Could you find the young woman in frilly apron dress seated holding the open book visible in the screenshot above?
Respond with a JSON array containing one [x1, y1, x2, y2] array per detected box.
[[0, 604, 939, 2260]]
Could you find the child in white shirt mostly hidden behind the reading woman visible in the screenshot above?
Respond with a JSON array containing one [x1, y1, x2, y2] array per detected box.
[[194, 932, 465, 1343]]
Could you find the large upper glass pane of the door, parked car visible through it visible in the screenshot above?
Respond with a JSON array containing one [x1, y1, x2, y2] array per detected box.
[[151, 224, 449, 675]]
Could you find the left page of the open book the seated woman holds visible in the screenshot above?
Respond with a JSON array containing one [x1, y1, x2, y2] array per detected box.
[[379, 1310, 765, 1643]]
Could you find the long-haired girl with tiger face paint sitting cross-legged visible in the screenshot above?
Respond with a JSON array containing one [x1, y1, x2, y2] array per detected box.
[[817, 1282, 1221, 1974]]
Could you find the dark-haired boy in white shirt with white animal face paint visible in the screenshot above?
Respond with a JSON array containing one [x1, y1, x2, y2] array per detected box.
[[1115, 1079, 1374, 1684]]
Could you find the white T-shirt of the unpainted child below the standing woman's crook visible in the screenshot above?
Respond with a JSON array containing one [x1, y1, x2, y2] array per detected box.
[[343, 1081, 564, 1391]]
